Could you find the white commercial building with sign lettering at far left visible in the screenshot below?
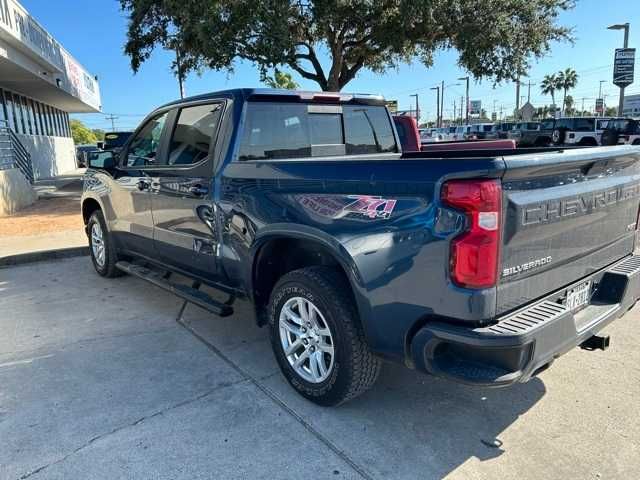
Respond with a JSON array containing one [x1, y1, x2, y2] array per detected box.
[[0, 0, 101, 183]]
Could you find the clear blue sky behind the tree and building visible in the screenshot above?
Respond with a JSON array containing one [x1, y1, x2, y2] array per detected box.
[[21, 0, 640, 130]]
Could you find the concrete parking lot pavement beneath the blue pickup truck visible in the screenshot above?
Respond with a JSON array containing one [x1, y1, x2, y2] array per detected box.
[[0, 253, 640, 479]]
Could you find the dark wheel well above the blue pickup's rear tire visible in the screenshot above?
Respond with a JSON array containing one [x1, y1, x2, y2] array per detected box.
[[253, 238, 355, 325]]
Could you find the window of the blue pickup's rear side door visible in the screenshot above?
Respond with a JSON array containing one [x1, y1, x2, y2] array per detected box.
[[167, 104, 222, 165]]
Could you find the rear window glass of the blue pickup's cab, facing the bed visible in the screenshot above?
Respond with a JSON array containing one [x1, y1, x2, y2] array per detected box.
[[239, 102, 397, 160]]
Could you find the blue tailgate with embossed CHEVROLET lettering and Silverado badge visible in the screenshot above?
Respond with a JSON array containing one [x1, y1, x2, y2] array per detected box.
[[497, 146, 640, 314]]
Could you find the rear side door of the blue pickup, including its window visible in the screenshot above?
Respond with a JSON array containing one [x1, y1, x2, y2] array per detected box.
[[151, 101, 224, 280]]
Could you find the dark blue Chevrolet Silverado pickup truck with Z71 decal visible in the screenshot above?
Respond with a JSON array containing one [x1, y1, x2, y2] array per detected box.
[[82, 89, 640, 405]]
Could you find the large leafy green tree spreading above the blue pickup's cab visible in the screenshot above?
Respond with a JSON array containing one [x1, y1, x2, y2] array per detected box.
[[120, 0, 574, 91]]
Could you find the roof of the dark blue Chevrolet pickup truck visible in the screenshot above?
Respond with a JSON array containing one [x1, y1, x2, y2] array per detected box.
[[160, 88, 385, 108]]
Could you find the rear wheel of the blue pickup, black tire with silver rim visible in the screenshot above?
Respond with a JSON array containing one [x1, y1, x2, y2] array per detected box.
[[269, 266, 382, 406]]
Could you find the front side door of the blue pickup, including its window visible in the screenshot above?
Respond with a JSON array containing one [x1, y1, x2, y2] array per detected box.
[[109, 112, 168, 256]]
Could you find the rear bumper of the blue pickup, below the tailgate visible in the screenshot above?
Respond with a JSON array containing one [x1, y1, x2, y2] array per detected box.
[[411, 255, 640, 387]]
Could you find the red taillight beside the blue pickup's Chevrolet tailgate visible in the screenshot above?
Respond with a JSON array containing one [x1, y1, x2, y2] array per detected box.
[[442, 180, 502, 288]]
